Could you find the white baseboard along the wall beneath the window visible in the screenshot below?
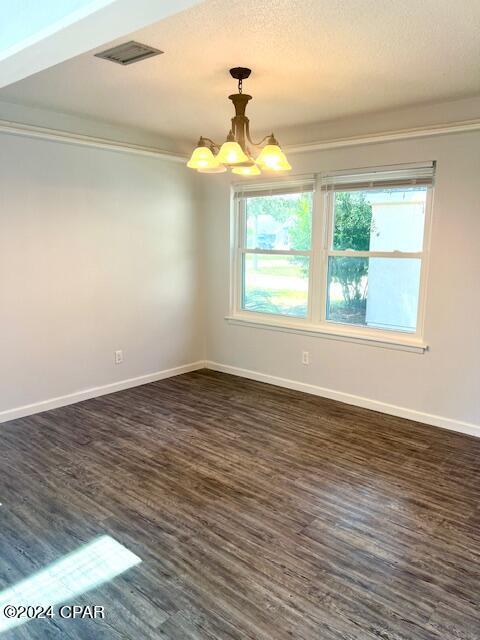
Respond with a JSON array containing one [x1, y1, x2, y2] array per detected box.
[[205, 360, 480, 438]]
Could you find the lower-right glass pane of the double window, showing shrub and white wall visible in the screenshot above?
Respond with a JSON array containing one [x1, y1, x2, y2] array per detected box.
[[327, 256, 421, 332]]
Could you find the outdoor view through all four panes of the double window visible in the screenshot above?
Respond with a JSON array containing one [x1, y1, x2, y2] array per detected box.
[[242, 186, 426, 332]]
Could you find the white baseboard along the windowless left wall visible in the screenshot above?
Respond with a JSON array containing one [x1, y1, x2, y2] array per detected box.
[[0, 360, 205, 423]]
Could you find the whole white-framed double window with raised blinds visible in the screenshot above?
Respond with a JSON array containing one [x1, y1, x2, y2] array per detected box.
[[231, 164, 434, 344]]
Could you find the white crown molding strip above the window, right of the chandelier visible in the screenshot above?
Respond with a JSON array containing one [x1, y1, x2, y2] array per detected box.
[[285, 119, 480, 153]]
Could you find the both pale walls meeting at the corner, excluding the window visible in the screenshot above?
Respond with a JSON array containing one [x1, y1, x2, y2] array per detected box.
[[0, 125, 480, 433]]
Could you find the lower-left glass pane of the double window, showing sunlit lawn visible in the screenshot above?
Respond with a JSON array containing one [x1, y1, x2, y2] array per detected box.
[[242, 253, 310, 318]]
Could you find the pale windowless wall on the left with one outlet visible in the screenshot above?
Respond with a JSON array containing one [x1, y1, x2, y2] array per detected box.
[[0, 134, 204, 418]]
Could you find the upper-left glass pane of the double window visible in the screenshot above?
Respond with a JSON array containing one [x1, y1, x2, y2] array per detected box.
[[245, 193, 313, 251]]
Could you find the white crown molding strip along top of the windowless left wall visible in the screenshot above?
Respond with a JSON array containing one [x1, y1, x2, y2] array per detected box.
[[0, 120, 186, 162]]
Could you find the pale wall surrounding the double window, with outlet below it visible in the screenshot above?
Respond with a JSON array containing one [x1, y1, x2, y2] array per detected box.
[[204, 132, 480, 435]]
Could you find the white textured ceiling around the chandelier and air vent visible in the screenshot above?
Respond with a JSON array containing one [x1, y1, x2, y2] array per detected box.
[[0, 0, 480, 145]]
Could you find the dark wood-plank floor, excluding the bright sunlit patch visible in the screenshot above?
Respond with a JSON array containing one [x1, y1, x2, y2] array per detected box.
[[0, 371, 480, 640]]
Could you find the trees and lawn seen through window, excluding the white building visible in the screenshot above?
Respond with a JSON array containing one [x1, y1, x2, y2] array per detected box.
[[244, 192, 372, 322]]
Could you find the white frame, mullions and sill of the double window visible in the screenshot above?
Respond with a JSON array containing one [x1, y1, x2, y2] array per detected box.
[[225, 167, 433, 353]]
